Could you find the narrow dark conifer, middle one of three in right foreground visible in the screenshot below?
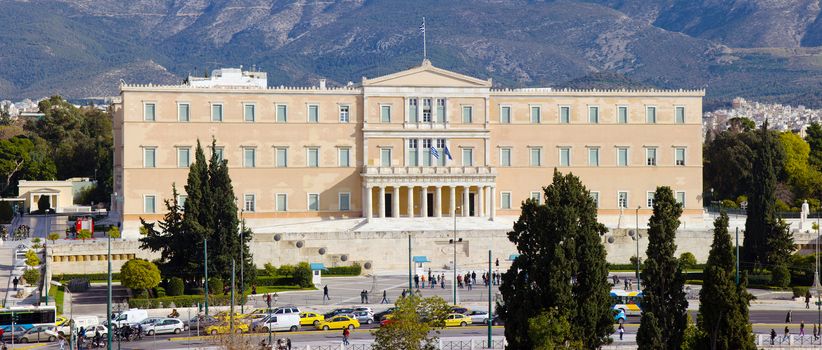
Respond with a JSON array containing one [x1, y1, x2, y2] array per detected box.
[[637, 186, 688, 349]]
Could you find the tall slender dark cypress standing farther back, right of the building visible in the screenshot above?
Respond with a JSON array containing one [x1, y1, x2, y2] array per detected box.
[[743, 120, 778, 267]]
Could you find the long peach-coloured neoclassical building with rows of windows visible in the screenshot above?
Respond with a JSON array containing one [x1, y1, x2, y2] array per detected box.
[[113, 61, 704, 238]]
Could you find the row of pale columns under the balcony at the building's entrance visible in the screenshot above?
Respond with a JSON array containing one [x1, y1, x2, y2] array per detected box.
[[363, 186, 496, 220]]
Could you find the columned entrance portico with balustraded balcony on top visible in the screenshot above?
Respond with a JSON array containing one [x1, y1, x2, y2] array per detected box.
[[362, 166, 496, 220]]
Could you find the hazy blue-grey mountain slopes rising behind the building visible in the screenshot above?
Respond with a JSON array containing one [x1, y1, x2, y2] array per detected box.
[[0, 0, 822, 108]]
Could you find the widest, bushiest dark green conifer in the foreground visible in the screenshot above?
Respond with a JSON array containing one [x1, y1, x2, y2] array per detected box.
[[498, 172, 613, 349]]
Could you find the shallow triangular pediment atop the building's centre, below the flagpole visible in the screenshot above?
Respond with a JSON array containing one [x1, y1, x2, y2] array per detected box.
[[362, 60, 491, 88]]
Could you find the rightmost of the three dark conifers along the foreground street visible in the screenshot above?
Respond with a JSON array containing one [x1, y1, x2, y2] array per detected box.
[[697, 211, 756, 350]]
